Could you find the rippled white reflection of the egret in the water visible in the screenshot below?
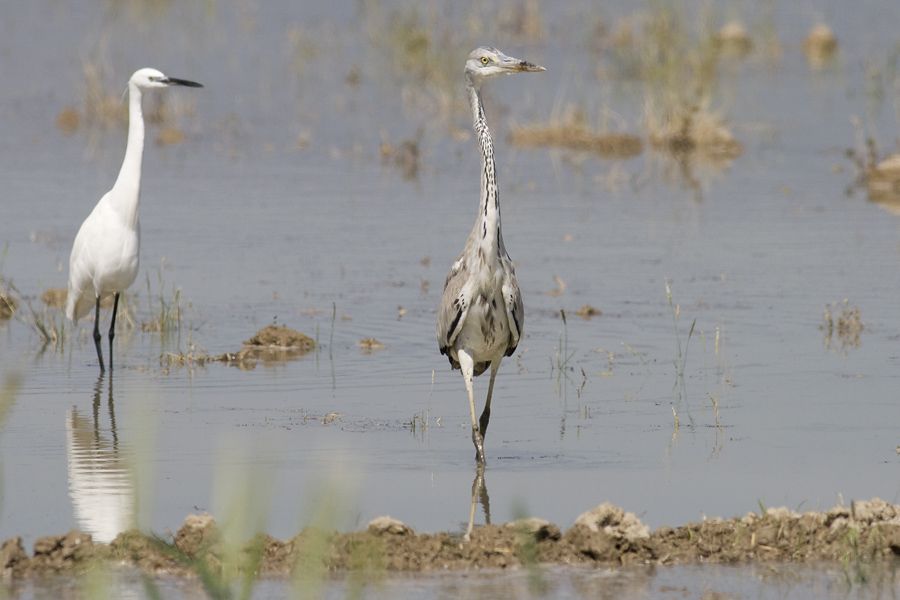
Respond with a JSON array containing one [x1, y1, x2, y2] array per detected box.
[[66, 375, 134, 543]]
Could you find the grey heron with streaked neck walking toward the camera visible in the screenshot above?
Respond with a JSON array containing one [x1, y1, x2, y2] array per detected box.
[[437, 48, 545, 463]]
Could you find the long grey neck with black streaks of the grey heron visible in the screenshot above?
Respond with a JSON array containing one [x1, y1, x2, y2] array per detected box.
[[468, 82, 505, 257]]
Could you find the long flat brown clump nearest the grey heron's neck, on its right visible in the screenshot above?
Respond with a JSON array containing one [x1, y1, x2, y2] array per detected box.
[[509, 110, 644, 159]]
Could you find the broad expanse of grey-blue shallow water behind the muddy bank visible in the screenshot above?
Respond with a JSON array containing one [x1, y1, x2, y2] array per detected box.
[[0, 1, 900, 577]]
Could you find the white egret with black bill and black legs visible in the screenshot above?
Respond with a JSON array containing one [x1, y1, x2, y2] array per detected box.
[[66, 69, 203, 371]]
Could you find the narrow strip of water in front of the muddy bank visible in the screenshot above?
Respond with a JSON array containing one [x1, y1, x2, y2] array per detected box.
[[7, 565, 900, 600]]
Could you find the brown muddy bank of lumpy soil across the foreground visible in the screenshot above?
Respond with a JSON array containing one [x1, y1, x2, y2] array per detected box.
[[0, 498, 900, 577]]
